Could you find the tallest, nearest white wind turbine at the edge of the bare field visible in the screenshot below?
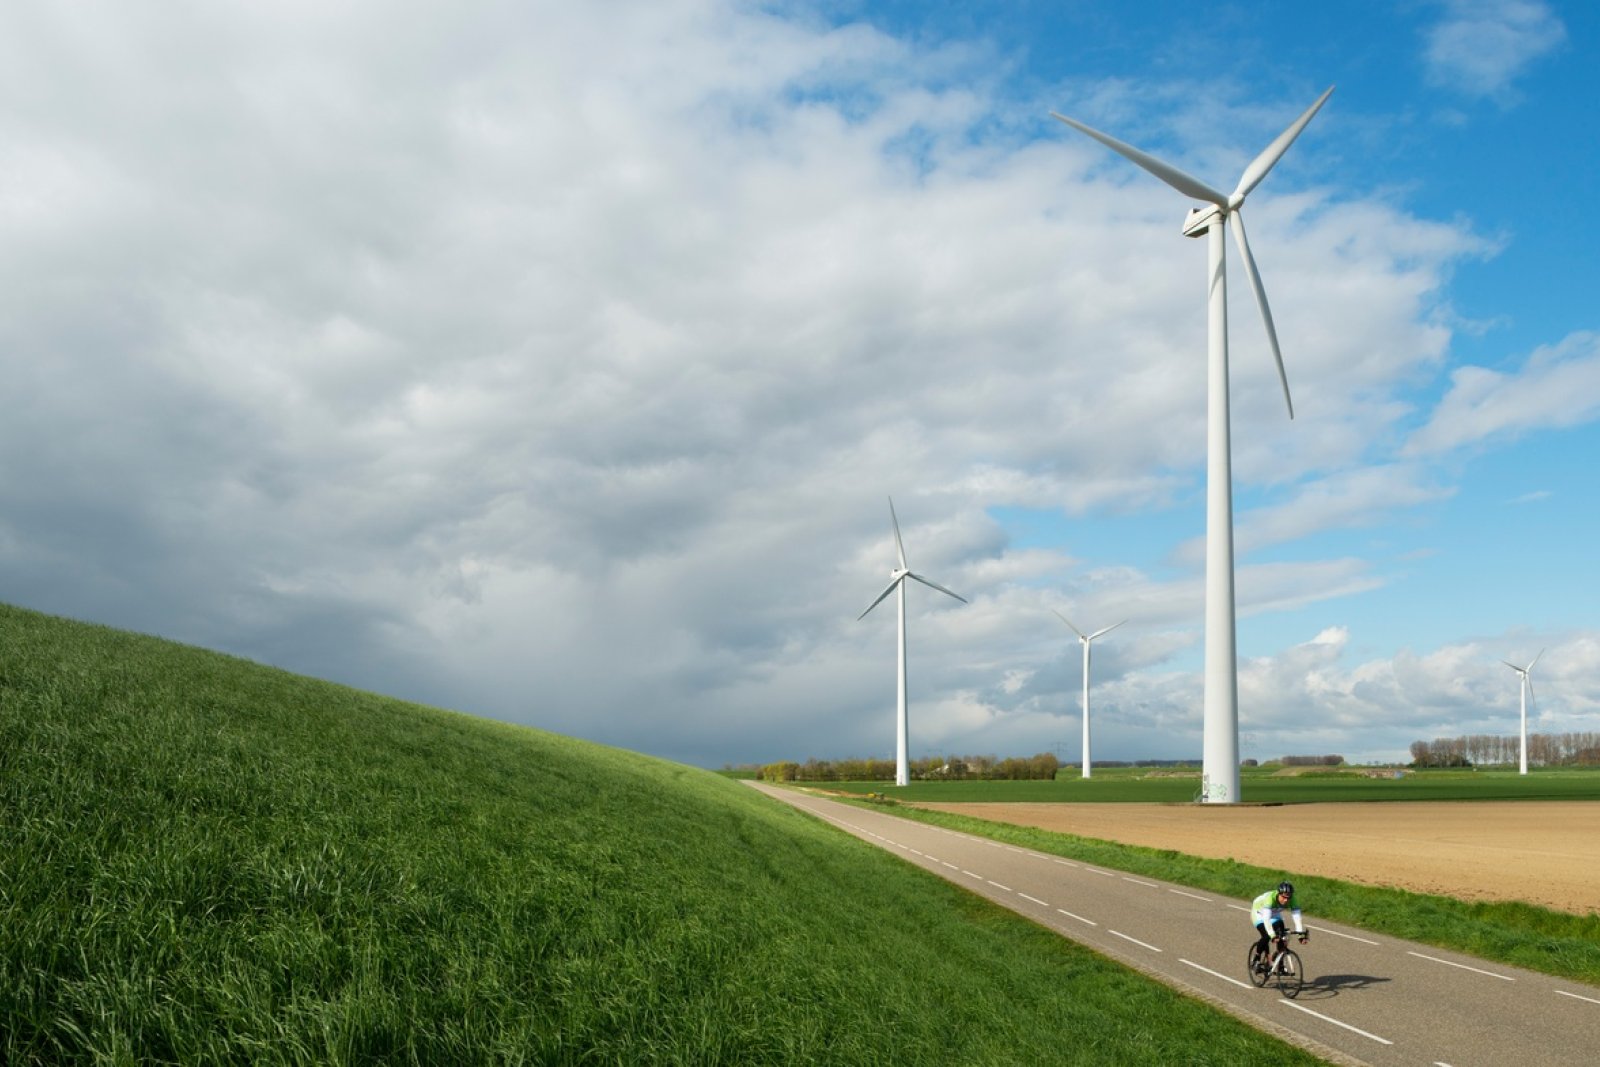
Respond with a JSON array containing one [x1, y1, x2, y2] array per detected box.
[[1051, 85, 1333, 803]]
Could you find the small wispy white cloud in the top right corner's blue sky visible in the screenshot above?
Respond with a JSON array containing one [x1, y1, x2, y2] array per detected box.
[[1424, 0, 1566, 101]]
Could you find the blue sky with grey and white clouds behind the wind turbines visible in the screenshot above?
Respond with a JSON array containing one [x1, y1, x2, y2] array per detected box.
[[0, 0, 1600, 768]]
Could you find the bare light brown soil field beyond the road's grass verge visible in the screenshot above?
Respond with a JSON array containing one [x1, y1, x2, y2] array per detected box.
[[917, 801, 1600, 915]]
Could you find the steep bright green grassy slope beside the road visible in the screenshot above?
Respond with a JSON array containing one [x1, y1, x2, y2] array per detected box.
[[0, 608, 1312, 1065]]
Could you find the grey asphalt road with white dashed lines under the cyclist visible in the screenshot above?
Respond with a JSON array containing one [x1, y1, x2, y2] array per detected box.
[[750, 782, 1600, 1067]]
